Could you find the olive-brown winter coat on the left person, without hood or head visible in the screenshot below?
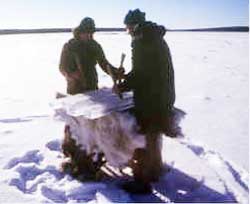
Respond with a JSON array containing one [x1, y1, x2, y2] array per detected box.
[[59, 39, 114, 94]]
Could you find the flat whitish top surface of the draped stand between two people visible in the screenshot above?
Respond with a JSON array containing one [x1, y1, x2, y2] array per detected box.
[[51, 88, 134, 120]]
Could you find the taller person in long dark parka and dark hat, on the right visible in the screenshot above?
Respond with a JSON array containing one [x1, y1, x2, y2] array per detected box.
[[119, 9, 175, 192]]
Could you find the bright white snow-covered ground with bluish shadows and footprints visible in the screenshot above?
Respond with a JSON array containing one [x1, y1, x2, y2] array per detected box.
[[0, 32, 249, 203]]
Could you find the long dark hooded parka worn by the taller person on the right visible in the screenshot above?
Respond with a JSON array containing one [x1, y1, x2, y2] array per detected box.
[[123, 22, 175, 131]]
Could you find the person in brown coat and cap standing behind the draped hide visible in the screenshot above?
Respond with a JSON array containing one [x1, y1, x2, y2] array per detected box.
[[59, 17, 121, 94]]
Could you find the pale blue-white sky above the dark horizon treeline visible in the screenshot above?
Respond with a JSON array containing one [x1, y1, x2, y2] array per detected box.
[[0, 0, 249, 29]]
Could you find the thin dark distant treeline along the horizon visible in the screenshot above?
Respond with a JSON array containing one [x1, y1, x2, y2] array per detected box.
[[0, 26, 249, 35]]
